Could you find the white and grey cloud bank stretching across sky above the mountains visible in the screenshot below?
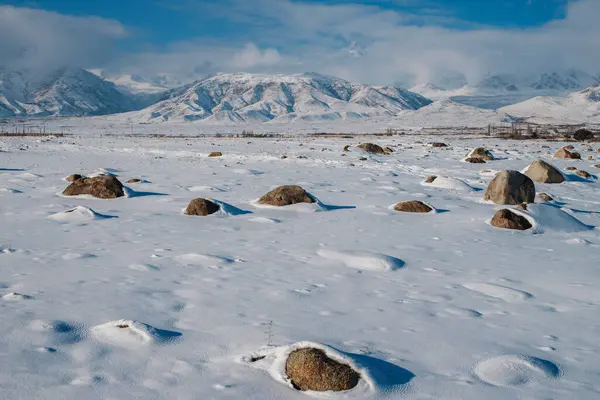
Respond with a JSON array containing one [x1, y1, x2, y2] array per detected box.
[[0, 0, 600, 83]]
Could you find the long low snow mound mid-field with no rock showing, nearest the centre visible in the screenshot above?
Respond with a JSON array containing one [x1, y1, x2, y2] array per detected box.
[[317, 249, 404, 271]]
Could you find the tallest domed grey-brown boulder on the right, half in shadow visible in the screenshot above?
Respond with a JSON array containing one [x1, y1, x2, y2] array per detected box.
[[483, 171, 535, 205]]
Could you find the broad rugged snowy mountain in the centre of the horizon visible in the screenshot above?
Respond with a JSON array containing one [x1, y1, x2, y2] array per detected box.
[[128, 73, 431, 122]]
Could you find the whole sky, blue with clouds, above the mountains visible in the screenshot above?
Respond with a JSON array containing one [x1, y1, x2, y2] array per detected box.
[[0, 0, 600, 84]]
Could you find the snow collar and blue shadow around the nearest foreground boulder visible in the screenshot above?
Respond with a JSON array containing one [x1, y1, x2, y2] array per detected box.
[[241, 342, 415, 399]]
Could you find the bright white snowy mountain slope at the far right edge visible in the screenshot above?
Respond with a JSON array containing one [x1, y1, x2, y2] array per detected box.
[[499, 84, 600, 123]]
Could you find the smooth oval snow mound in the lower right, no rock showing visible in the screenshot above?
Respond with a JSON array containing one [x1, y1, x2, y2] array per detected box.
[[473, 355, 561, 387]]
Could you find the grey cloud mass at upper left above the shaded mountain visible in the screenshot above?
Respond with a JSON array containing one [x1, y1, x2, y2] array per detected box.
[[0, 6, 127, 69]]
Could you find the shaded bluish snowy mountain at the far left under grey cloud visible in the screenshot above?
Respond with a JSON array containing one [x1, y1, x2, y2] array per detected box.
[[0, 68, 137, 117]]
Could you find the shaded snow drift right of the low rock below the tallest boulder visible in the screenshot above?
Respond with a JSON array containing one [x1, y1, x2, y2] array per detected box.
[[511, 204, 594, 233]]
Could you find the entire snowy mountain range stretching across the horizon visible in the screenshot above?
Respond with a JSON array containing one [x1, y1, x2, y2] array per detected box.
[[0, 67, 600, 124]]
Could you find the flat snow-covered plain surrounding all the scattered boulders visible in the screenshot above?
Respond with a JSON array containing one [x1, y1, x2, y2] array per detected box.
[[0, 131, 600, 400]]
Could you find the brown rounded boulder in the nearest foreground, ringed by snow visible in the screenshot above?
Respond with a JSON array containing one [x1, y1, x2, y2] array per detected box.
[[285, 348, 360, 392]]
